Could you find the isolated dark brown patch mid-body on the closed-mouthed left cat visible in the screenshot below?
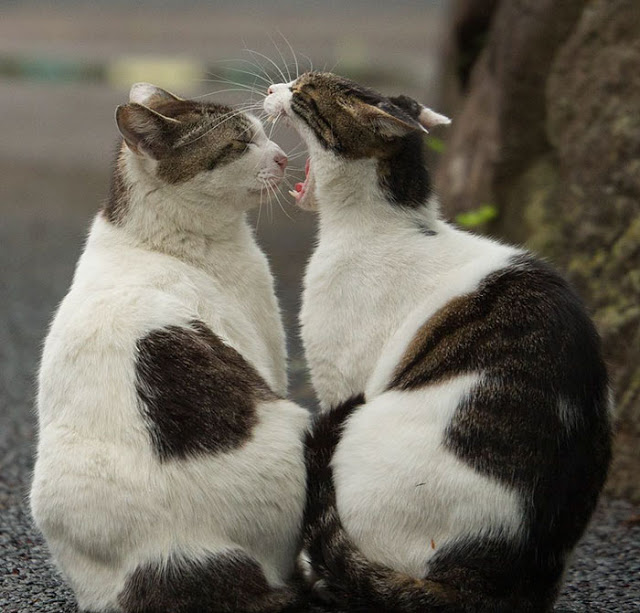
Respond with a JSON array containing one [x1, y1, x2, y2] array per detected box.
[[136, 321, 277, 461]]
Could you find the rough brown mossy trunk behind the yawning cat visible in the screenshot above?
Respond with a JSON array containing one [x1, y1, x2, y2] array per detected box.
[[436, 0, 640, 502]]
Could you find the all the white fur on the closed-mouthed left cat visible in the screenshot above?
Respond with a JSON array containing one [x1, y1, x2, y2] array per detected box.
[[31, 122, 308, 611]]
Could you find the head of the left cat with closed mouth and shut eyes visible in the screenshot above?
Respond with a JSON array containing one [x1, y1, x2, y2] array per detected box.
[[116, 83, 287, 205]]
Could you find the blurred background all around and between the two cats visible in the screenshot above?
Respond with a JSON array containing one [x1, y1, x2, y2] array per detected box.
[[0, 0, 640, 612]]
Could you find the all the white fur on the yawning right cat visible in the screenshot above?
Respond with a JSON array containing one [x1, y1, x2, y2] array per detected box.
[[265, 84, 523, 577]]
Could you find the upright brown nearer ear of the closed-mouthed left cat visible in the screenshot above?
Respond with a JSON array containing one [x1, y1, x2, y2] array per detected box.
[[116, 103, 180, 160]]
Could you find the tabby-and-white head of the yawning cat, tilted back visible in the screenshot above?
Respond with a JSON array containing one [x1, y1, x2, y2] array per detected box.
[[264, 72, 450, 208]]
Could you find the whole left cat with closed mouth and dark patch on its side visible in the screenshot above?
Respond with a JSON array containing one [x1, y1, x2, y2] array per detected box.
[[31, 83, 308, 613]]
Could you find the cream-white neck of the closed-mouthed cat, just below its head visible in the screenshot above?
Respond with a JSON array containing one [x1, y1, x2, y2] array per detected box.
[[111, 151, 253, 263]]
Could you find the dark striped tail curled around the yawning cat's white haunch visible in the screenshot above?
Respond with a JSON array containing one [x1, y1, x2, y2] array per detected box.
[[305, 396, 529, 613]]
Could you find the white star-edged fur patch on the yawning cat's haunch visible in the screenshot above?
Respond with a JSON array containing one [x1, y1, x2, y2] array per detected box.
[[332, 374, 522, 578]]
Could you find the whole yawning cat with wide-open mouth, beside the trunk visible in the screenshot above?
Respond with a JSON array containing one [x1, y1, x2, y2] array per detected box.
[[264, 72, 611, 613]]
